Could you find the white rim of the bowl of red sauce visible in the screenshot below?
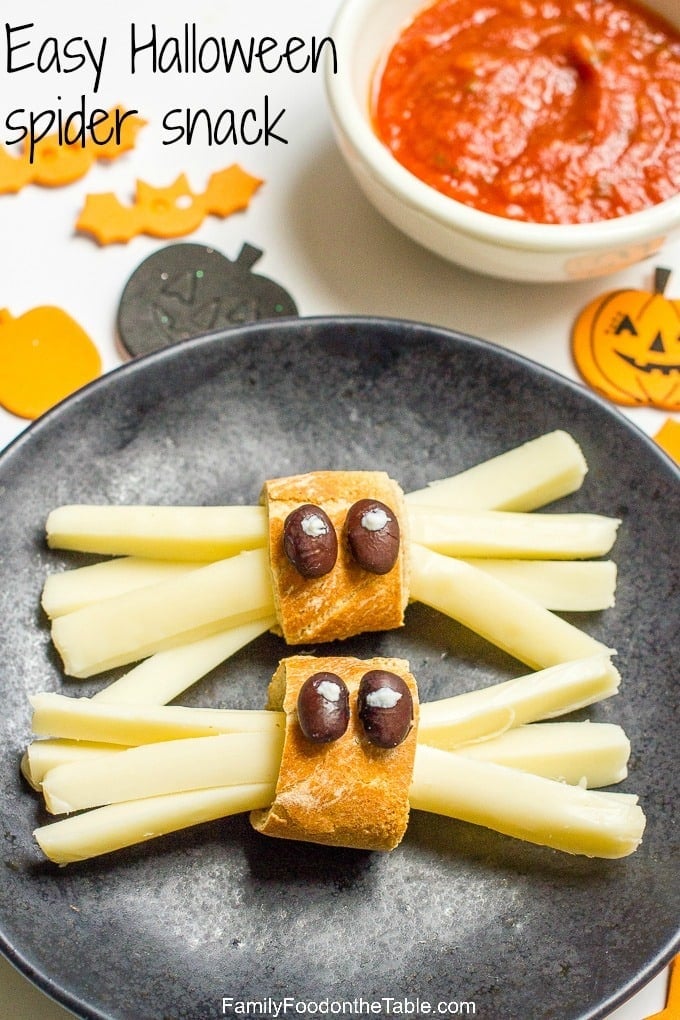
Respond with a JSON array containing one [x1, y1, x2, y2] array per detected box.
[[324, 0, 680, 252]]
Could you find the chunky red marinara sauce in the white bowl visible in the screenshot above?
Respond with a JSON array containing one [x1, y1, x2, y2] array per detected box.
[[373, 0, 680, 223]]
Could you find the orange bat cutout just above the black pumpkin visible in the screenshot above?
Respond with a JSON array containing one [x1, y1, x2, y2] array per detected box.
[[75, 169, 263, 245]]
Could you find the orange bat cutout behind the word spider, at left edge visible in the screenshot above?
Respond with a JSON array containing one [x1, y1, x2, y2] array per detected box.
[[0, 106, 147, 194]]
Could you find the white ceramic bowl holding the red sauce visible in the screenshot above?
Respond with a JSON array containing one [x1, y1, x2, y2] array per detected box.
[[326, 0, 680, 283]]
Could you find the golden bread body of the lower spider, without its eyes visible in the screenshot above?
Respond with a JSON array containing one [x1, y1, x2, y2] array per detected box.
[[251, 655, 418, 850]]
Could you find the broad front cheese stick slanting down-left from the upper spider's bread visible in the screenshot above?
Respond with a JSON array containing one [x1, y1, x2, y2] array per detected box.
[[52, 549, 273, 677]]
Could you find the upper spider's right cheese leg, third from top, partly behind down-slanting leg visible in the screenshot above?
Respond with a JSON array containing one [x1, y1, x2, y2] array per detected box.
[[465, 559, 617, 613]]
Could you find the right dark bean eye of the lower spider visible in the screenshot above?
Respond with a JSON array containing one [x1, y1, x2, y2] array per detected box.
[[357, 669, 413, 748]]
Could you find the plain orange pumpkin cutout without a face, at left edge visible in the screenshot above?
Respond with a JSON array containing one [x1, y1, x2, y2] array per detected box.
[[0, 305, 102, 418]]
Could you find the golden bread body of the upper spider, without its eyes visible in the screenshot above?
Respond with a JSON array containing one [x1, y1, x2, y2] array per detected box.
[[262, 471, 409, 645]]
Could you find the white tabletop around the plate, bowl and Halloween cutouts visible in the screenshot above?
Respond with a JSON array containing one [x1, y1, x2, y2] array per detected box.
[[0, 0, 680, 1020]]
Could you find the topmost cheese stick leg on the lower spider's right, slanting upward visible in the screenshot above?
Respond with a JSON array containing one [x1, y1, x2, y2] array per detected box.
[[418, 653, 621, 750]]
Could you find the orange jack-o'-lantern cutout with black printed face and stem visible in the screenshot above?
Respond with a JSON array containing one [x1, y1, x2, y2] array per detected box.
[[572, 268, 680, 411]]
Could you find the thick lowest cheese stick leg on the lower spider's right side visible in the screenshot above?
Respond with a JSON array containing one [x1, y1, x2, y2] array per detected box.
[[409, 745, 645, 859]]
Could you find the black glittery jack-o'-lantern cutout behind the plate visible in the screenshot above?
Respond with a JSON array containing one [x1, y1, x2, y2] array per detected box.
[[117, 244, 298, 357]]
